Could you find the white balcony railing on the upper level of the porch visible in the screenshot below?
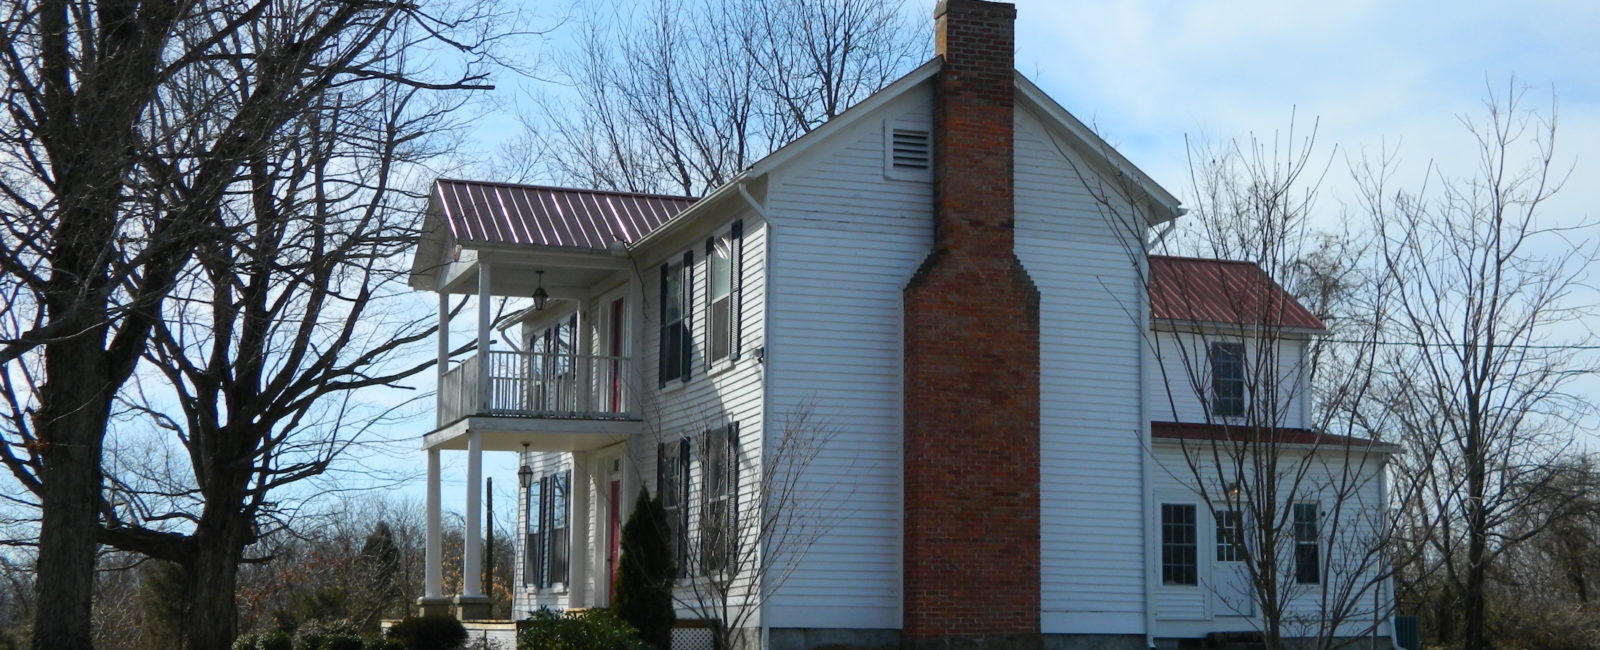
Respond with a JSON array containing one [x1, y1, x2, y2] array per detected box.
[[438, 351, 634, 426]]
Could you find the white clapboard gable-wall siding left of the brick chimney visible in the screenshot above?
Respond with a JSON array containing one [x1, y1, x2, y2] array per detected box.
[[768, 86, 933, 628]]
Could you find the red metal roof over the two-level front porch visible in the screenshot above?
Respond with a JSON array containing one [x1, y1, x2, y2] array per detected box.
[[434, 179, 696, 250]]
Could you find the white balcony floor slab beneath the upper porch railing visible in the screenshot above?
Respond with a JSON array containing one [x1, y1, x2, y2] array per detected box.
[[422, 415, 645, 451]]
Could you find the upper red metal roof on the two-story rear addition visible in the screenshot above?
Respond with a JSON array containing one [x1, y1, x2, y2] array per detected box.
[[1150, 255, 1325, 330]]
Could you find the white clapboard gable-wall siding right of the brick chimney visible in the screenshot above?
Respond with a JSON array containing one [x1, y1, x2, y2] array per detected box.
[[1016, 110, 1144, 634]]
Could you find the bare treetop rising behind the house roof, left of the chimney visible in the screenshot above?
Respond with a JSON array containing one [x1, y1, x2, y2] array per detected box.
[[504, 0, 926, 195]]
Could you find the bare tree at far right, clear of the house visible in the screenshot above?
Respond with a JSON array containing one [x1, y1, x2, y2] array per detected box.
[[1357, 82, 1597, 648]]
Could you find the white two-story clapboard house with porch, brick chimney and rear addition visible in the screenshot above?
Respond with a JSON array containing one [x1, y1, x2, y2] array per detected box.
[[411, 0, 1390, 648]]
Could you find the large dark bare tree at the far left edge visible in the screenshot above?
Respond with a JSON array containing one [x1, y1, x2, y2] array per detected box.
[[0, 0, 482, 648]]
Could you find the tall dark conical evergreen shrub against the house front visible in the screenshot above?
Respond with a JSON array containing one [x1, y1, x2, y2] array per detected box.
[[611, 488, 677, 650]]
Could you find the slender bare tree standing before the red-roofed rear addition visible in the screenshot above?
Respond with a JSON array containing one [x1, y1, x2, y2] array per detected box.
[[1149, 126, 1406, 648]]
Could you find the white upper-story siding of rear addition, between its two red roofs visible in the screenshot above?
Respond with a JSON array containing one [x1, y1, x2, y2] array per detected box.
[[1146, 331, 1309, 427]]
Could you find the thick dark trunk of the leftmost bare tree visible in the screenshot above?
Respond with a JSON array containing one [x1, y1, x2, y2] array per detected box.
[[32, 330, 110, 650]]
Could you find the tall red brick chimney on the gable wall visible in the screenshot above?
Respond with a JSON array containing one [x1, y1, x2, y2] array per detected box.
[[902, 0, 1040, 648]]
